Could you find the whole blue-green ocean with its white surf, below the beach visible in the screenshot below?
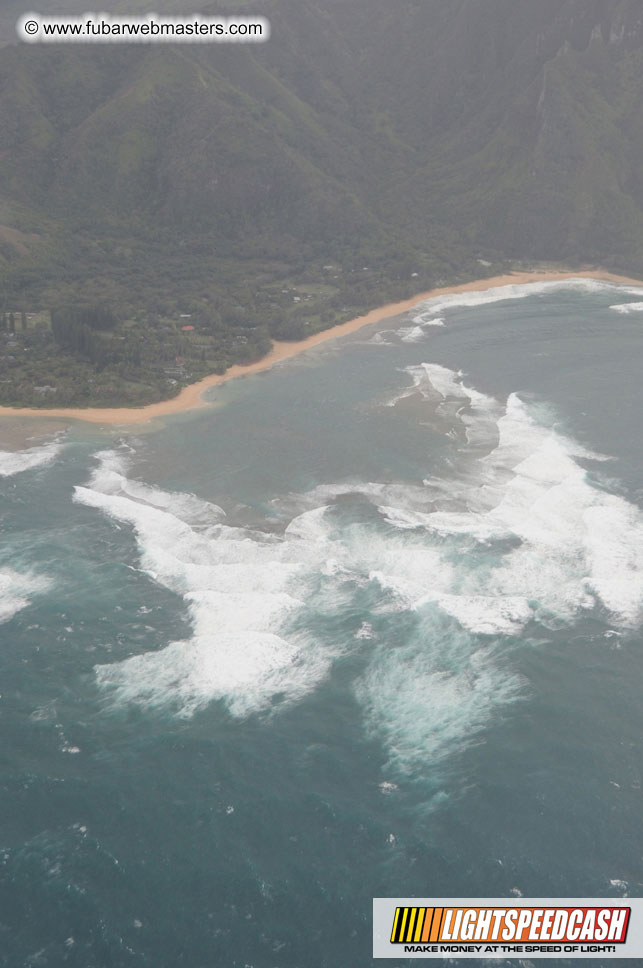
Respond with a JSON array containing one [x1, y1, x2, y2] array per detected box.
[[0, 280, 643, 968]]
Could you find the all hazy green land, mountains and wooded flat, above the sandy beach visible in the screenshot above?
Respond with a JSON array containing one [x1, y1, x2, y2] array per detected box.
[[0, 0, 643, 406]]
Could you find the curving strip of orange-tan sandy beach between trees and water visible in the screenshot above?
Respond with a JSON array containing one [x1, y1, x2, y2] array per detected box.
[[0, 269, 643, 425]]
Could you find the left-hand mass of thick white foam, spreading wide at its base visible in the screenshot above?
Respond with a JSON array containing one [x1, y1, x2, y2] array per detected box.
[[74, 453, 350, 715]]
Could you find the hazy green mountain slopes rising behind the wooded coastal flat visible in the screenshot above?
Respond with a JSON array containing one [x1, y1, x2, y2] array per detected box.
[[0, 0, 643, 306]]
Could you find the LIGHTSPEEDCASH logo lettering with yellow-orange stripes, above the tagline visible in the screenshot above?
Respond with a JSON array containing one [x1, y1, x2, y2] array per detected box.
[[391, 907, 631, 944]]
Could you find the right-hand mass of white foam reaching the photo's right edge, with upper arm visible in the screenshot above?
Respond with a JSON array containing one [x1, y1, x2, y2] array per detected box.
[[307, 365, 643, 635]]
